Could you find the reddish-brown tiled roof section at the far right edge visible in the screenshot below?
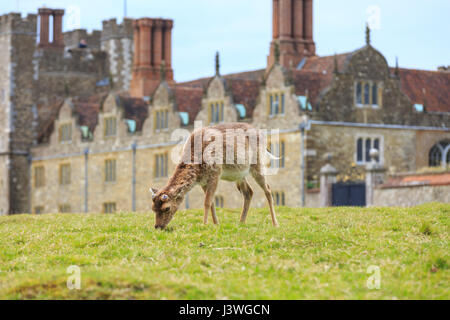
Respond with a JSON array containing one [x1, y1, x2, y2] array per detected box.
[[392, 69, 450, 112]]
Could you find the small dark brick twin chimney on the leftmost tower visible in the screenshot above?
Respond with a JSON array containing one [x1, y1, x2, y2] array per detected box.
[[38, 8, 64, 49]]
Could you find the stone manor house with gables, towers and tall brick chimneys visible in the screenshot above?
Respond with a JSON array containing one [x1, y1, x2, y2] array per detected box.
[[0, 0, 450, 214]]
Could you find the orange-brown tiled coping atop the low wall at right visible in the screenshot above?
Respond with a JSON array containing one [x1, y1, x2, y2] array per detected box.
[[381, 172, 450, 188]]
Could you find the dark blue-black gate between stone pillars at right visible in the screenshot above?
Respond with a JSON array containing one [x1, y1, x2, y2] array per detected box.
[[332, 182, 366, 207]]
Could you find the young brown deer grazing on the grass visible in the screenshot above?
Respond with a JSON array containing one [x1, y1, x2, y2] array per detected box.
[[150, 123, 278, 229]]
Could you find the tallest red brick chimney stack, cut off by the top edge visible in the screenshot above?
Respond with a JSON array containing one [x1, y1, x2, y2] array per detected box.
[[267, 0, 316, 69]]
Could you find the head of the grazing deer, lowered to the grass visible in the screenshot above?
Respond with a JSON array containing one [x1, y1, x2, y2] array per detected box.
[[150, 188, 179, 229]]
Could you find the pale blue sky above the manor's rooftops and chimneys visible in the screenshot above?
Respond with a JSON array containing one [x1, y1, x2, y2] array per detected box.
[[0, 0, 450, 82]]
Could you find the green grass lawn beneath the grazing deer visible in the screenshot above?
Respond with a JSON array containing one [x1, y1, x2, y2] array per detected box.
[[0, 204, 450, 299]]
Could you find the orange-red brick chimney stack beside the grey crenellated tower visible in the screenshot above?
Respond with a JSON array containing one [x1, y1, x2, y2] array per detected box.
[[130, 18, 173, 97]]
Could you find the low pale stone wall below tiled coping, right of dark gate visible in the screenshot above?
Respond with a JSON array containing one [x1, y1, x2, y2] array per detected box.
[[374, 186, 450, 207]]
